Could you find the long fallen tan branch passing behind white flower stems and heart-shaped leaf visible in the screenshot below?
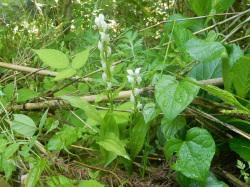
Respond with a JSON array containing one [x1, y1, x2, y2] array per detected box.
[[11, 78, 223, 110]]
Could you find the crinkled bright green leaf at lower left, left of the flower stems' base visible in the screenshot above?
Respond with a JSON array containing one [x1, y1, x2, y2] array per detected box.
[[47, 125, 81, 151]]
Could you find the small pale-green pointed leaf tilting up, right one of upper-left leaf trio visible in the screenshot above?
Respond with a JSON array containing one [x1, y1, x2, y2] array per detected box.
[[71, 48, 90, 70]]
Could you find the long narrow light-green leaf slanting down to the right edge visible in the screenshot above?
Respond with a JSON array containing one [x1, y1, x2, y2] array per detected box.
[[201, 85, 249, 112]]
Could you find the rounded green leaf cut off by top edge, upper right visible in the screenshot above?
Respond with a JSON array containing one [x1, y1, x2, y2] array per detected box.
[[188, 0, 212, 16]]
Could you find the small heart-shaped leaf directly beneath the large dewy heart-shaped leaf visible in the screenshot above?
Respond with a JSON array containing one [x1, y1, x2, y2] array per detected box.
[[161, 116, 186, 140]]
